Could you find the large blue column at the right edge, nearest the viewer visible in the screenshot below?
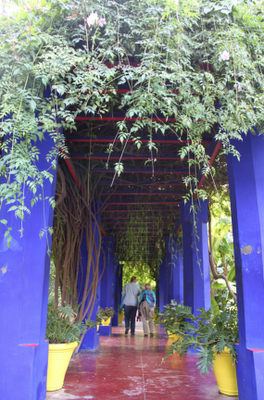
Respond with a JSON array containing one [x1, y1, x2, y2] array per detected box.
[[227, 132, 264, 400]]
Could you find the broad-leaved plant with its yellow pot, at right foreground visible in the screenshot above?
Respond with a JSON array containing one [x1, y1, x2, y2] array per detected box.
[[164, 301, 239, 396]]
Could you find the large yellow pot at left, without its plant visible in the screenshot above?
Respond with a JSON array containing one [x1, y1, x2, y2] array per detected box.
[[47, 342, 78, 392]]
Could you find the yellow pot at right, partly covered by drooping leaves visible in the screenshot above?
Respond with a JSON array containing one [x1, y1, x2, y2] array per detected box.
[[213, 347, 238, 396]]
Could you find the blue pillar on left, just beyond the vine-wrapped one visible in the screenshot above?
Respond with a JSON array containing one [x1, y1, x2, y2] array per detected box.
[[99, 237, 116, 335]]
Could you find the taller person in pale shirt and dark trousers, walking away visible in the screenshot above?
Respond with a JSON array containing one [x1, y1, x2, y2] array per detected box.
[[122, 276, 140, 335]]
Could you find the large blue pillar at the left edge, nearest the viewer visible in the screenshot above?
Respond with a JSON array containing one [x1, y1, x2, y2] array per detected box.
[[0, 134, 56, 400]]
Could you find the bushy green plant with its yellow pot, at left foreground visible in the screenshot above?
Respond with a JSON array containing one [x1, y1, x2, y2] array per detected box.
[[46, 303, 95, 391]]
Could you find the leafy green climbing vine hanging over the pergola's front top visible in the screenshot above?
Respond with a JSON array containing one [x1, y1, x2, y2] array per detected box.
[[0, 0, 264, 233]]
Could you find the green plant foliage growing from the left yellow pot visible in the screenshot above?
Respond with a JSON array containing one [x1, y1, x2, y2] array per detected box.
[[46, 302, 95, 343]]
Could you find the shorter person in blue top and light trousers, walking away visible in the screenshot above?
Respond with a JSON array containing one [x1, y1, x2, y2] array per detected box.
[[139, 283, 156, 336]]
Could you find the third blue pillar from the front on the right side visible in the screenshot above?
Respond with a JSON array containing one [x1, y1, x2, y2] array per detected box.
[[166, 238, 184, 303]]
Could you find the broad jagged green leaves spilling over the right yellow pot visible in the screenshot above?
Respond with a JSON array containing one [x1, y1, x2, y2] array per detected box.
[[165, 302, 239, 375]]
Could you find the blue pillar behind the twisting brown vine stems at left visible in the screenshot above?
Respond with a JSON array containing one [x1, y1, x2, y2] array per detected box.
[[78, 206, 101, 351]]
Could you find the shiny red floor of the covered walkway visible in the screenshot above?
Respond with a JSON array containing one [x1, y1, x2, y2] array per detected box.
[[47, 323, 238, 400]]
